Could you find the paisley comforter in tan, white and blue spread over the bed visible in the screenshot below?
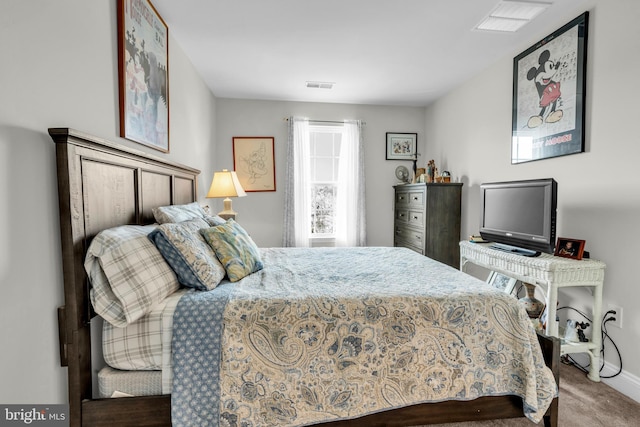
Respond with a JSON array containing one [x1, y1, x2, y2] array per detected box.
[[172, 248, 557, 427]]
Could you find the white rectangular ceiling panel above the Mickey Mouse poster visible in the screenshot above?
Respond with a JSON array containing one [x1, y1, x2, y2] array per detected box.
[[475, 0, 551, 33]]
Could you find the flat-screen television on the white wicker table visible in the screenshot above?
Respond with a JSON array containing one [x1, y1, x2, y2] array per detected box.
[[480, 178, 558, 256]]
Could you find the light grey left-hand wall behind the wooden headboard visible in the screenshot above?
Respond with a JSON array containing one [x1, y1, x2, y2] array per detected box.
[[0, 0, 215, 404]]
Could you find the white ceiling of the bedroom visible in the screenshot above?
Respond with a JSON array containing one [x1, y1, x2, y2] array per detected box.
[[151, 0, 593, 106]]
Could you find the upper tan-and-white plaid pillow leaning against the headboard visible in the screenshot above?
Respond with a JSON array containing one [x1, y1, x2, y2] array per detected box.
[[84, 225, 180, 327]]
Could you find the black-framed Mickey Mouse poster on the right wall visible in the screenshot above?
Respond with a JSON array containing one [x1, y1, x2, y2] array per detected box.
[[511, 12, 589, 164]]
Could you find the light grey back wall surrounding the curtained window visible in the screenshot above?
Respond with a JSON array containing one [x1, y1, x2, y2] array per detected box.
[[209, 98, 424, 247]]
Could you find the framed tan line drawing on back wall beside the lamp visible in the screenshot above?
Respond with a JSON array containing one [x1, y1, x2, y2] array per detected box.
[[233, 136, 276, 191]]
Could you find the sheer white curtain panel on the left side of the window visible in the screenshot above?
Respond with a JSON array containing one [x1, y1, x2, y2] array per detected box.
[[282, 117, 311, 247]]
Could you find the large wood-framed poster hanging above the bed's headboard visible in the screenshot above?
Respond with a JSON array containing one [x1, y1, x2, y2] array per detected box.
[[118, 0, 169, 153]]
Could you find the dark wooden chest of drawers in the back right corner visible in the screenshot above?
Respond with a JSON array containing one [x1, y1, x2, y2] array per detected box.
[[393, 183, 462, 268]]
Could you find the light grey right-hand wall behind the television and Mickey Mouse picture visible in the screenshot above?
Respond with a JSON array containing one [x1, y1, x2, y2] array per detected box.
[[426, 0, 640, 393]]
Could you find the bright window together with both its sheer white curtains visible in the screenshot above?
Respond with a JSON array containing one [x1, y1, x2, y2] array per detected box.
[[283, 118, 366, 246]]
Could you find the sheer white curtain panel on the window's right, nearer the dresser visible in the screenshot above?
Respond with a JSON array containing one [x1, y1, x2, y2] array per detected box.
[[336, 121, 366, 246]]
